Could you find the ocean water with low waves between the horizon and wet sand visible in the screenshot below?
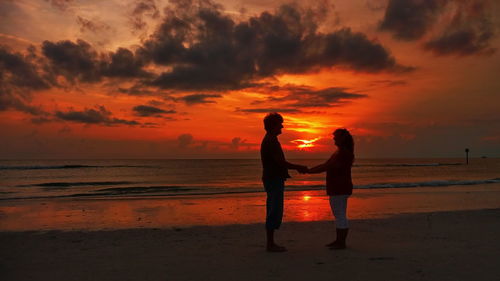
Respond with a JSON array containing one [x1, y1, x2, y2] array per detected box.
[[0, 158, 500, 200]]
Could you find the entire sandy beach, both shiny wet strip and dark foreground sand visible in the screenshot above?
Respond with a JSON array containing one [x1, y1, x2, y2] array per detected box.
[[0, 185, 500, 281]]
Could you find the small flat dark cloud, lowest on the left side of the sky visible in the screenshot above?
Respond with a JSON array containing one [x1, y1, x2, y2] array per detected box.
[[54, 106, 140, 126]]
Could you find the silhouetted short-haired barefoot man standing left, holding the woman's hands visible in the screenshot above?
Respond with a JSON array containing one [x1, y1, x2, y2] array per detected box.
[[260, 113, 307, 252]]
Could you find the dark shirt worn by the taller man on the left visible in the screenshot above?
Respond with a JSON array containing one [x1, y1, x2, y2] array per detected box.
[[260, 134, 290, 180]]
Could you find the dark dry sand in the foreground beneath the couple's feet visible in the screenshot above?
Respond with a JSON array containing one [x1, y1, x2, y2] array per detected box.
[[0, 209, 500, 281]]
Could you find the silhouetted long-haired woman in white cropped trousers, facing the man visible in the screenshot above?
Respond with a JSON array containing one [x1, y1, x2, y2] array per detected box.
[[309, 129, 354, 249]]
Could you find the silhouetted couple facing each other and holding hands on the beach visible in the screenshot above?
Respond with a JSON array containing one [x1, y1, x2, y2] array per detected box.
[[260, 113, 354, 252]]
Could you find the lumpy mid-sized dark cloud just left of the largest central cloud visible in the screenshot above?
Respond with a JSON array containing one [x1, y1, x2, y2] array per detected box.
[[42, 40, 149, 82]]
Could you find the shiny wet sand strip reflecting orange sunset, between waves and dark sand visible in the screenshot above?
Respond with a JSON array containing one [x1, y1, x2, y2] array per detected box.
[[0, 183, 500, 232]]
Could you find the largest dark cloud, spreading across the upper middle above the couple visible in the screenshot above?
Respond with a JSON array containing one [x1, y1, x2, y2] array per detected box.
[[140, 0, 409, 90]]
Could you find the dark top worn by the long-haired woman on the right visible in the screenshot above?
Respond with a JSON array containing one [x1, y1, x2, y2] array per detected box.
[[325, 149, 354, 196]]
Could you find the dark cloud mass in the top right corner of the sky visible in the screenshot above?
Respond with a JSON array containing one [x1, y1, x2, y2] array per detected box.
[[380, 0, 496, 56]]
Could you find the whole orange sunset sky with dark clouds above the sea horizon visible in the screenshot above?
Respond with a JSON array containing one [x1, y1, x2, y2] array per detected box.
[[0, 0, 500, 159]]
